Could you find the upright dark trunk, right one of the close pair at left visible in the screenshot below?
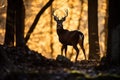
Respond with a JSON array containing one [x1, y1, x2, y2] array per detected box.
[[16, 0, 25, 47]]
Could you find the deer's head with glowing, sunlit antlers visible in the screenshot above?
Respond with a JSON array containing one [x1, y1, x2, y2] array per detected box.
[[52, 10, 68, 29]]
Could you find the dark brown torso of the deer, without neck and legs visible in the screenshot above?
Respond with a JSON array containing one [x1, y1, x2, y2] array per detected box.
[[57, 29, 83, 45]]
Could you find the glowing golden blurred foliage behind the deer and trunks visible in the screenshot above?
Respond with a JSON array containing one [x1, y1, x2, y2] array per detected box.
[[0, 0, 107, 60]]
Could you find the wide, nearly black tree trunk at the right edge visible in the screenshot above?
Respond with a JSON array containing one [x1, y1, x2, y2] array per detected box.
[[106, 0, 120, 64]]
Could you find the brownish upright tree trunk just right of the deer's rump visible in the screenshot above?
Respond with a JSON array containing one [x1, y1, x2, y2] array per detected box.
[[88, 0, 100, 60]]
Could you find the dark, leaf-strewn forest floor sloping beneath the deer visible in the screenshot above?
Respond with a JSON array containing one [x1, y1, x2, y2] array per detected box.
[[0, 45, 120, 80]]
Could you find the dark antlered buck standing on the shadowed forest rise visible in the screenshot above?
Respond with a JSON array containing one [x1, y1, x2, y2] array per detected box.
[[52, 10, 86, 62]]
